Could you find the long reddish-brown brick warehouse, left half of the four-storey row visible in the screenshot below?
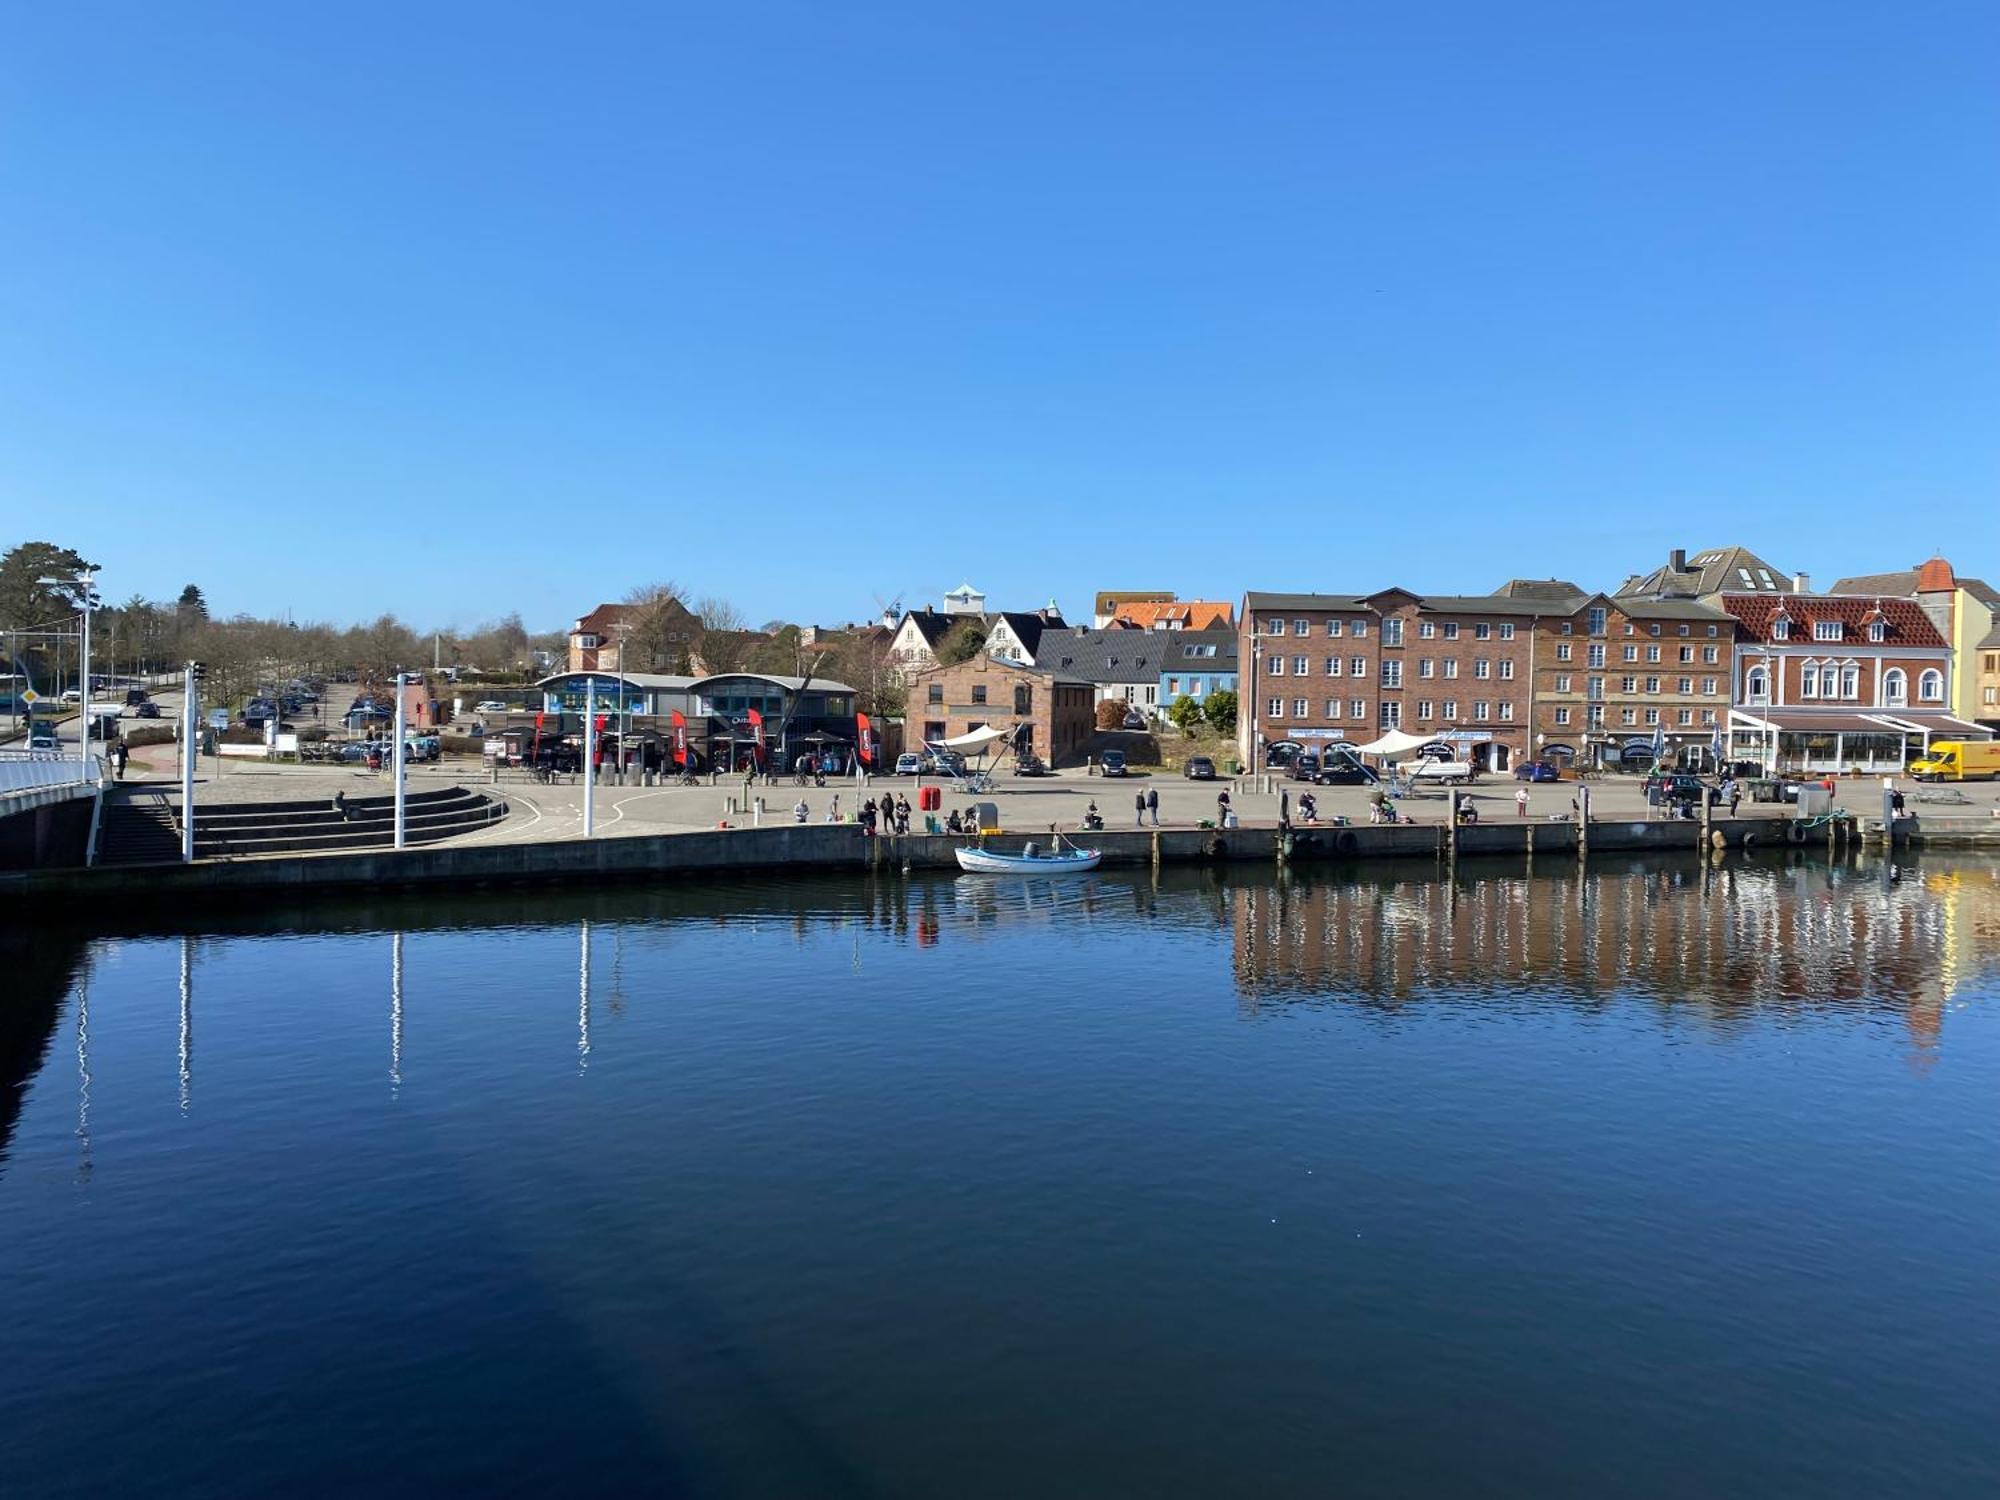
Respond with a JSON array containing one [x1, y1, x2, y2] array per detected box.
[[1238, 584, 1582, 770]]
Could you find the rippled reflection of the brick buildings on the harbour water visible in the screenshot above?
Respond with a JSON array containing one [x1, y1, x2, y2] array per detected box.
[[1232, 862, 2000, 1044]]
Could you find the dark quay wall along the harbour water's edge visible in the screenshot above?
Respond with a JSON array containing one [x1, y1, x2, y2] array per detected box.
[[0, 820, 1872, 904]]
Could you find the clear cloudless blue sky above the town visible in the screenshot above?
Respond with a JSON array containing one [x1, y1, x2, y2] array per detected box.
[[0, 0, 2000, 626]]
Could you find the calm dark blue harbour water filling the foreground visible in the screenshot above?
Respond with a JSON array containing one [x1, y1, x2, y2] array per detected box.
[[0, 854, 2000, 1496]]
